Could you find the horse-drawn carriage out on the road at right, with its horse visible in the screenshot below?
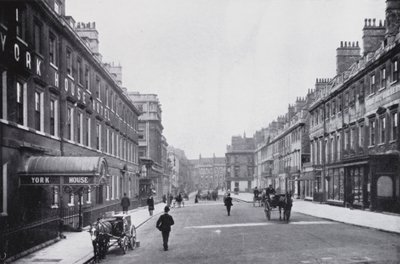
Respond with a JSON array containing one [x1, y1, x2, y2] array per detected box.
[[264, 193, 293, 222]]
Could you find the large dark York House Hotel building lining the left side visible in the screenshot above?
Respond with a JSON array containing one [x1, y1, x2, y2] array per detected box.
[[0, 0, 140, 256]]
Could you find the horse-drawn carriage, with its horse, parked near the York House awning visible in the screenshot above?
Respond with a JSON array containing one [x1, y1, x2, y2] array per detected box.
[[89, 214, 137, 261]]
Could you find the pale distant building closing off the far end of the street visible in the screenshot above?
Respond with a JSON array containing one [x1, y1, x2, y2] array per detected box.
[[190, 155, 226, 190]]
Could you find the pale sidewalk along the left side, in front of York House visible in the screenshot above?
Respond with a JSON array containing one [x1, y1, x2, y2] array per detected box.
[[13, 203, 166, 264]]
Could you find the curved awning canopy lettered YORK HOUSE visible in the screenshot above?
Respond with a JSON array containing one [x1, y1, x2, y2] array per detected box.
[[18, 156, 108, 185]]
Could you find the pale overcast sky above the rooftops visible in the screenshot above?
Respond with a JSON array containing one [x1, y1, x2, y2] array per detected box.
[[66, 0, 385, 159]]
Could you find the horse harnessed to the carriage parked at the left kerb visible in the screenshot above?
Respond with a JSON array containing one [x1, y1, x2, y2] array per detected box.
[[89, 219, 112, 262]]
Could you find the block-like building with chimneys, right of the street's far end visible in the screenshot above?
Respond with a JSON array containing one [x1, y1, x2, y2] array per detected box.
[[225, 135, 255, 191]]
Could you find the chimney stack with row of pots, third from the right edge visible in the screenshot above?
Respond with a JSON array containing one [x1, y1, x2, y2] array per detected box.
[[336, 41, 361, 75]]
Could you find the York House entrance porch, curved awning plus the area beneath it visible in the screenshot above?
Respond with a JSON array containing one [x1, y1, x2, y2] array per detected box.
[[18, 156, 108, 230]]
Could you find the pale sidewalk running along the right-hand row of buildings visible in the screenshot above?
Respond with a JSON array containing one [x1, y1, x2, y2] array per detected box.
[[231, 193, 400, 234]]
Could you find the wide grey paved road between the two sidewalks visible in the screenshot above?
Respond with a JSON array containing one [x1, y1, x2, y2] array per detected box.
[[102, 199, 400, 264]]
